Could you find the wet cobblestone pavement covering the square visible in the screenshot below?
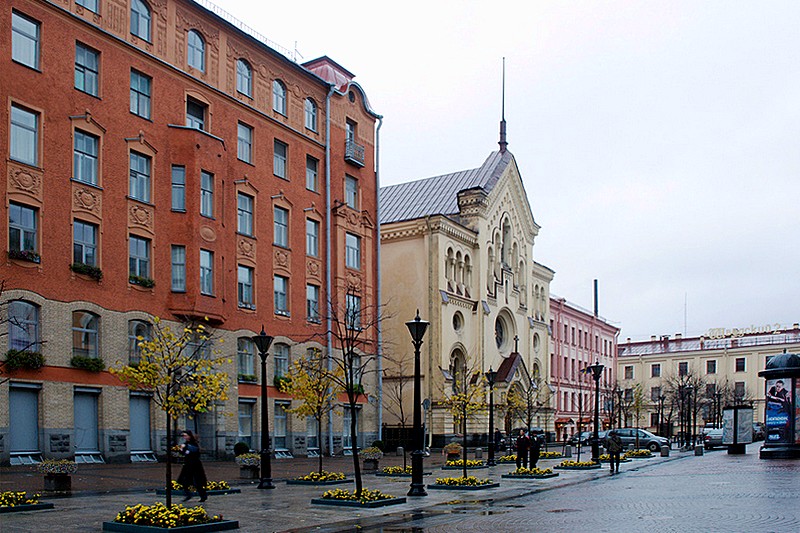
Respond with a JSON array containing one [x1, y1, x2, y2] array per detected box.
[[0, 443, 800, 533]]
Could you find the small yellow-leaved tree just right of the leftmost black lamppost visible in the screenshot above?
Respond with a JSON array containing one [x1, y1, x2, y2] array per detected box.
[[280, 348, 344, 473]]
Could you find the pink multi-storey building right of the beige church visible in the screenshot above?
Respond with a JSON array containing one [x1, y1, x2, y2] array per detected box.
[[550, 296, 619, 439]]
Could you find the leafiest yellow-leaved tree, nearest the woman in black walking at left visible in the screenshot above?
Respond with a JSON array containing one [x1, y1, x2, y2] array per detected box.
[[109, 317, 230, 507]]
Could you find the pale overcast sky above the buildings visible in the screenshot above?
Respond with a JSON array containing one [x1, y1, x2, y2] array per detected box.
[[216, 0, 800, 341]]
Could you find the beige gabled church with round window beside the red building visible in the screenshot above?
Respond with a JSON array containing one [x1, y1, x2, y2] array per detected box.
[[380, 143, 553, 447]]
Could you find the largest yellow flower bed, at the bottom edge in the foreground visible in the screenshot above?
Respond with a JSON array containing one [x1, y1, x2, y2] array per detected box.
[[103, 502, 239, 531]]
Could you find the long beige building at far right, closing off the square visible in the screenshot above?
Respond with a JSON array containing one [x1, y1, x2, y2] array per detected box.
[[617, 324, 800, 434]]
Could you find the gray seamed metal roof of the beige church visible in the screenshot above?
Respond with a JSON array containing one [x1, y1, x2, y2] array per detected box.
[[379, 151, 514, 224]]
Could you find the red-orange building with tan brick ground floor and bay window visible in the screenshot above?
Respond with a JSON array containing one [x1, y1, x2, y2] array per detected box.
[[0, 0, 380, 462]]
